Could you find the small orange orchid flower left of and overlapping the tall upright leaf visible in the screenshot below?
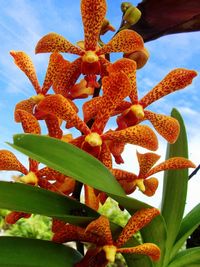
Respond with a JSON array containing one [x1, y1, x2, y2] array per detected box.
[[112, 152, 195, 196]]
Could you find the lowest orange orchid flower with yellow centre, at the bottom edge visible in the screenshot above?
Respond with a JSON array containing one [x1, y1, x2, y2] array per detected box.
[[53, 208, 160, 267]]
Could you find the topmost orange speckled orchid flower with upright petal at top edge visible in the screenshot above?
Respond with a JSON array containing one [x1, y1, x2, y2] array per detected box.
[[35, 0, 143, 90]]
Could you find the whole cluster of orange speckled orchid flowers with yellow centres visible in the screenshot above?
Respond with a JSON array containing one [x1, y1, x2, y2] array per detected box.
[[0, 0, 196, 266]]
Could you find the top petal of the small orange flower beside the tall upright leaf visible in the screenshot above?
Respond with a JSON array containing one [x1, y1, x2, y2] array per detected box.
[[137, 152, 160, 178]]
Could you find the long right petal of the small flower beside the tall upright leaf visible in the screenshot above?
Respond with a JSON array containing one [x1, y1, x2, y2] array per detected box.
[[146, 157, 195, 177]]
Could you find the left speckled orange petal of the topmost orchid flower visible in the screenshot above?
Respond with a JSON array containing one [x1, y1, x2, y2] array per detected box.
[[35, 32, 83, 55]]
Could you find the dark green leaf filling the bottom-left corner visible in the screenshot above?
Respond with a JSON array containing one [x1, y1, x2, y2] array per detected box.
[[0, 237, 82, 267]]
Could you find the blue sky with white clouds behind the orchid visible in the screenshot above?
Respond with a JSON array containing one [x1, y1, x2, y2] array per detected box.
[[0, 0, 200, 214]]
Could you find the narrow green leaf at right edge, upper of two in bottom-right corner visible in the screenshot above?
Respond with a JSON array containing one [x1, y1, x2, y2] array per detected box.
[[171, 204, 200, 259]]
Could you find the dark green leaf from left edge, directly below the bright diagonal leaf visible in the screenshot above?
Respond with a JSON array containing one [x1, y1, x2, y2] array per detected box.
[[0, 181, 99, 225]]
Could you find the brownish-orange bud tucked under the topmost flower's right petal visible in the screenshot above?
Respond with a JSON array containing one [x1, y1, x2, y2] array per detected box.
[[124, 48, 149, 69]]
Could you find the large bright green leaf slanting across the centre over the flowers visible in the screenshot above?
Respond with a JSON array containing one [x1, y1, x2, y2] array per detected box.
[[11, 134, 150, 213]]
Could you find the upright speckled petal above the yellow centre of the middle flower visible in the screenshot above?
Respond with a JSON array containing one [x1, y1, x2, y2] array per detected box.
[[91, 72, 131, 134]]
